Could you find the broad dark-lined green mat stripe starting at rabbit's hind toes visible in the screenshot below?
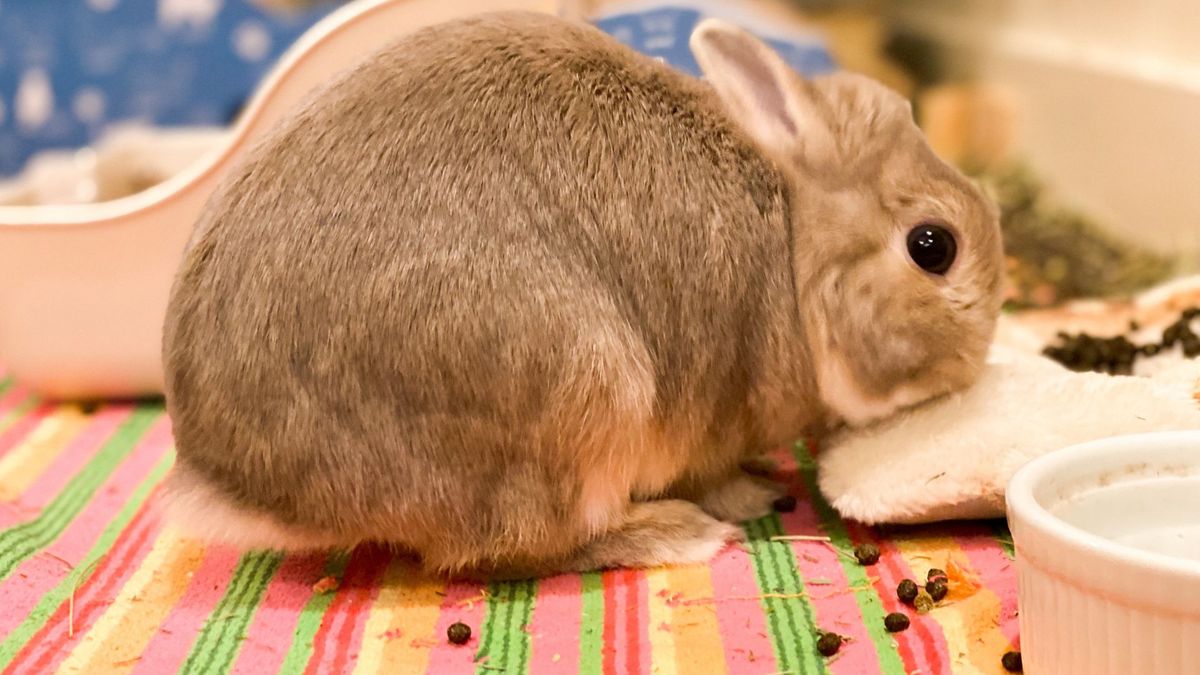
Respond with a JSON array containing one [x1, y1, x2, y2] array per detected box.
[[745, 515, 824, 673]]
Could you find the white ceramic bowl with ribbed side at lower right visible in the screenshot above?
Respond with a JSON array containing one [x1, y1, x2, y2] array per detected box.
[[1007, 431, 1200, 675]]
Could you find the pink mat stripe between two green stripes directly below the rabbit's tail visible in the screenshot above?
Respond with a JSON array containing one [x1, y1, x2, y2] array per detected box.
[[233, 555, 325, 675]]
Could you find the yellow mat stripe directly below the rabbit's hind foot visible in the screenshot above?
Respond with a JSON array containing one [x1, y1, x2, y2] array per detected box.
[[670, 565, 726, 675]]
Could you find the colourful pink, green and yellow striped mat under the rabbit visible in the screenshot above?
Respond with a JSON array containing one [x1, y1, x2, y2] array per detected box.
[[0, 375, 1016, 675]]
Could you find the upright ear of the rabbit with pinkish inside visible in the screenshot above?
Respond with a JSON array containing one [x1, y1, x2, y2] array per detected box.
[[690, 19, 834, 161]]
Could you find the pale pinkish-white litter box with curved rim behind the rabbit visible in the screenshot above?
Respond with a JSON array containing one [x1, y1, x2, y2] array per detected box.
[[0, 0, 557, 399]]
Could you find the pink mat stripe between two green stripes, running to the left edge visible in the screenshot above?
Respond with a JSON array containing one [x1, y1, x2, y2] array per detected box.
[[0, 417, 170, 635]]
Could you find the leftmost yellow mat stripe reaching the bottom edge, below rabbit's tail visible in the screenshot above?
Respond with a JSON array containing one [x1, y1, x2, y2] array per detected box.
[[58, 530, 204, 674]]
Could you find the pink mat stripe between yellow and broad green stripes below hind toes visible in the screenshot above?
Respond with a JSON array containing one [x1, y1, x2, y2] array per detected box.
[[712, 546, 779, 675]]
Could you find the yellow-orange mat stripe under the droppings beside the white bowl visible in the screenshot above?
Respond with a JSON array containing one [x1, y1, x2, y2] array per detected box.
[[896, 537, 1009, 674]]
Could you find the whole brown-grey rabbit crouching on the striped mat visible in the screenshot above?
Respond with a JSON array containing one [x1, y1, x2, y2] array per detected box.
[[163, 12, 1002, 578]]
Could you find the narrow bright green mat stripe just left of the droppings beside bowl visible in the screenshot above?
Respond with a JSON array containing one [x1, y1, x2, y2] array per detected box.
[[793, 443, 905, 675]]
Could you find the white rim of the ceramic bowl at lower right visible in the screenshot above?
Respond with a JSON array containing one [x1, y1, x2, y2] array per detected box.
[[1004, 430, 1200, 580]]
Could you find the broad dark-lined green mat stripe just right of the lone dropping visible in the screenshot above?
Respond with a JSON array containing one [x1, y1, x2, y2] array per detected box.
[[475, 581, 538, 675]]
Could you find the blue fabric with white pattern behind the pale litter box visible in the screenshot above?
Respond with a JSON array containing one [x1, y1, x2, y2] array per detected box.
[[0, 0, 833, 175]]
